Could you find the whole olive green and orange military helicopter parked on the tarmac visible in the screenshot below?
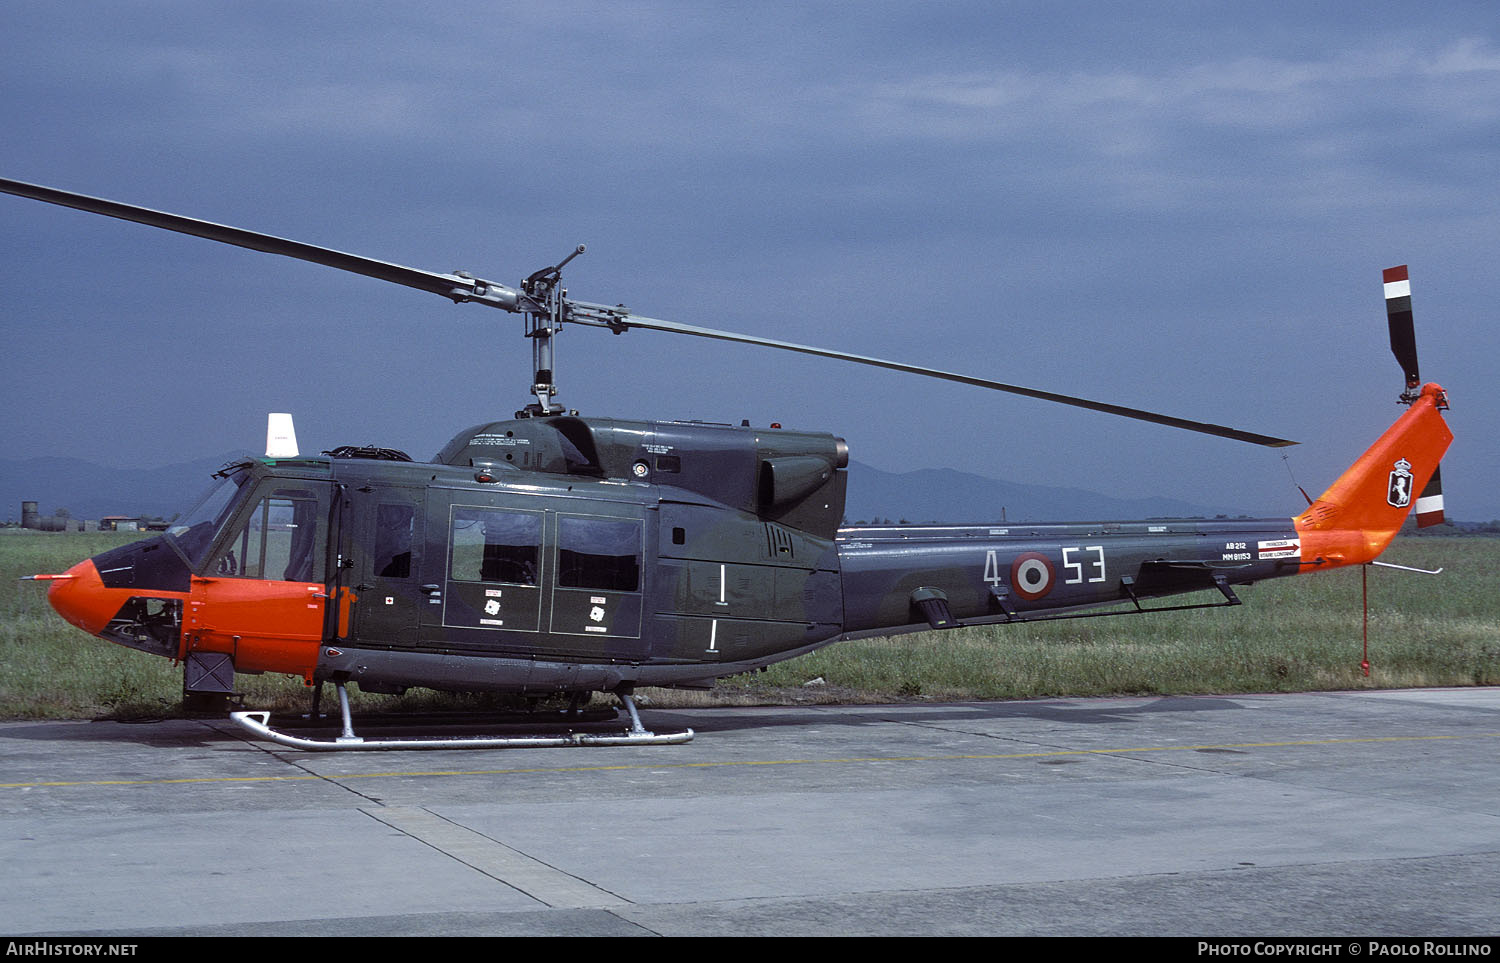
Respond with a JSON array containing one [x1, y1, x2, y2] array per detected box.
[[0, 180, 1452, 750]]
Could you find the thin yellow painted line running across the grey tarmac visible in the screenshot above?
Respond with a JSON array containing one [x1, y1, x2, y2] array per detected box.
[[0, 732, 1500, 789]]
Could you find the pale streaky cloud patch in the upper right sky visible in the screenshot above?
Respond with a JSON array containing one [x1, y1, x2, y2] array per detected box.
[[827, 36, 1500, 228]]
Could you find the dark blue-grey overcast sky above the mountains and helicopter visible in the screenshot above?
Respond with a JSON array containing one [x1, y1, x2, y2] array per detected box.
[[0, 0, 1500, 519]]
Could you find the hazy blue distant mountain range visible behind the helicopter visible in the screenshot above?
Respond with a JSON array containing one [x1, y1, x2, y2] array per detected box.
[[0, 452, 1242, 522]]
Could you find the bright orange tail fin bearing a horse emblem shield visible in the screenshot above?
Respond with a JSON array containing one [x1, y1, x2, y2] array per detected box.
[[1293, 384, 1454, 567]]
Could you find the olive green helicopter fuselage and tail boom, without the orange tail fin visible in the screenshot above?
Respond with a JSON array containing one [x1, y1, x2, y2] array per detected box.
[[76, 417, 1299, 693]]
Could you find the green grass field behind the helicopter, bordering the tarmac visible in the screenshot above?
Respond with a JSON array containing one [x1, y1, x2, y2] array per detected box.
[[0, 533, 1500, 719]]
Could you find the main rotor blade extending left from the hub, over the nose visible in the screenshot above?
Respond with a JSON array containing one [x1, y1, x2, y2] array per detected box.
[[0, 177, 516, 311]]
